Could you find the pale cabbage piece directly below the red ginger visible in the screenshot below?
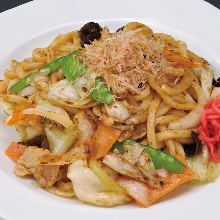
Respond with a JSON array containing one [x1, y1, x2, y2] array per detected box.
[[187, 146, 220, 182]]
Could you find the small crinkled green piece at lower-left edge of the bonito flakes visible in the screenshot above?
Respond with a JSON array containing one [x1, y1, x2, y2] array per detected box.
[[89, 78, 113, 104]]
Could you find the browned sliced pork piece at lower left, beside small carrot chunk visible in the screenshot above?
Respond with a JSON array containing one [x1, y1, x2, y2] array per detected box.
[[14, 147, 86, 188]]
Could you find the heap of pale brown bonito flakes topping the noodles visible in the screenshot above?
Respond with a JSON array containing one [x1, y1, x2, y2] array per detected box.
[[82, 31, 170, 97]]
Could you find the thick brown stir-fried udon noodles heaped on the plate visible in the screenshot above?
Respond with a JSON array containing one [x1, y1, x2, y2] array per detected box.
[[0, 23, 212, 197]]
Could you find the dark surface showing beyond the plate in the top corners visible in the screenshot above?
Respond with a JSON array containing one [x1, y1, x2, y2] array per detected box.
[[0, 0, 220, 12]]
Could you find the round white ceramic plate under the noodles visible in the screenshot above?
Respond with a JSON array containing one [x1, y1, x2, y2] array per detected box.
[[0, 0, 220, 220]]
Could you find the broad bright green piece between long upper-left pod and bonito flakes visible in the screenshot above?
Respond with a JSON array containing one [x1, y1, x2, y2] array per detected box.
[[61, 55, 86, 82]]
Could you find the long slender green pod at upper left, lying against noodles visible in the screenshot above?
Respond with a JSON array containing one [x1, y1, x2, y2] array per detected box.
[[40, 50, 80, 74]]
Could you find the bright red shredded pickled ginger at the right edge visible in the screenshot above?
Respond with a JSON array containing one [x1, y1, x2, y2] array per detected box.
[[199, 99, 220, 163]]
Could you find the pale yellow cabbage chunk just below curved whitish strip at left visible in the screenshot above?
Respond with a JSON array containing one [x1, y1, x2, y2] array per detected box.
[[45, 126, 78, 154]]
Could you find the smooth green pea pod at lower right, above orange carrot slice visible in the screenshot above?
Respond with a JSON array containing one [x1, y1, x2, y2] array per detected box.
[[144, 145, 186, 173]]
